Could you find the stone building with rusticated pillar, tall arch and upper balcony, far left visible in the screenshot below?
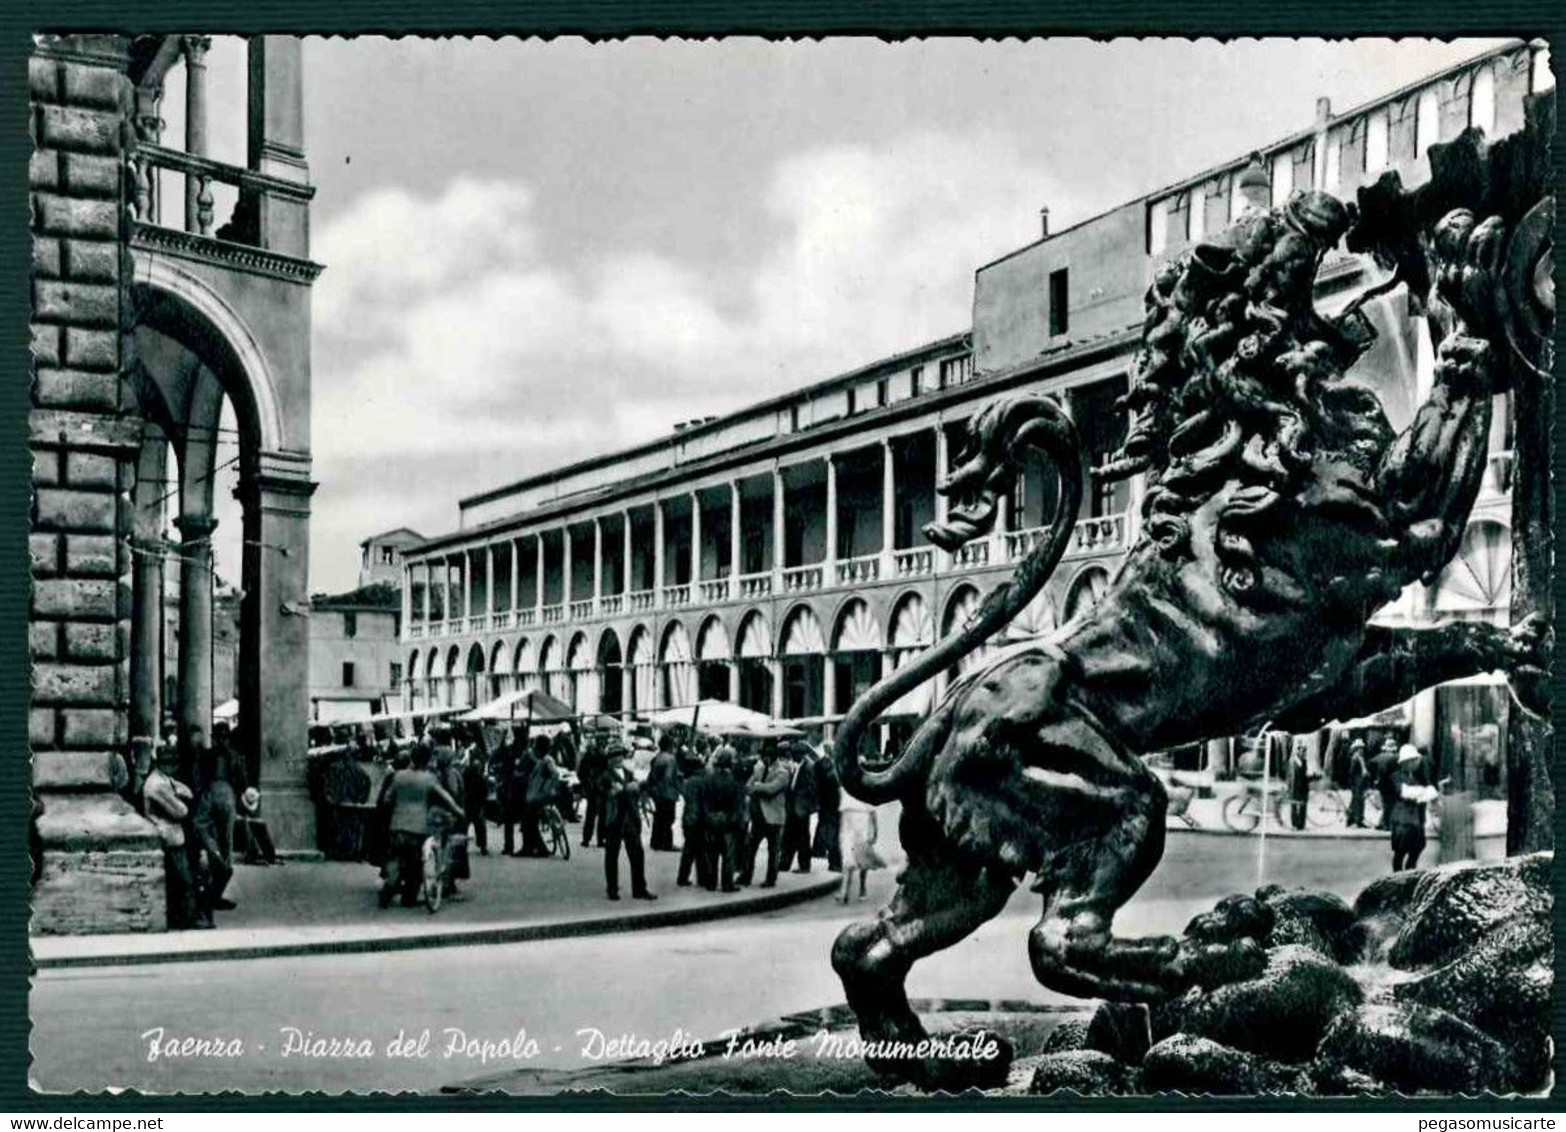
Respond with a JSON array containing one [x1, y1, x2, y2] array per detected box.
[[28, 36, 319, 933]]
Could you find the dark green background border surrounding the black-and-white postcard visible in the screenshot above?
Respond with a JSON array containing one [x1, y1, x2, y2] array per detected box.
[[0, 0, 1566, 1115]]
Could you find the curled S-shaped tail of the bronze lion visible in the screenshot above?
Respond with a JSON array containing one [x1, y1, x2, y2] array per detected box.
[[833, 393, 1084, 805]]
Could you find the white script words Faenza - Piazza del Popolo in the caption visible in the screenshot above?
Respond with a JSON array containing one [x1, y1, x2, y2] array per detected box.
[[141, 1026, 539, 1065]]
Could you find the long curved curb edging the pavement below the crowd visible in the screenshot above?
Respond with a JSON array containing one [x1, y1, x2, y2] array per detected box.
[[33, 875, 843, 971]]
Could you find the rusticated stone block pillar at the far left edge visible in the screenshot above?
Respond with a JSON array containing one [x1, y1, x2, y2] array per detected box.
[[28, 36, 164, 933]]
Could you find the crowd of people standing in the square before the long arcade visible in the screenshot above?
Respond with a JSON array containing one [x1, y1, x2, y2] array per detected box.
[[360, 723, 883, 907]]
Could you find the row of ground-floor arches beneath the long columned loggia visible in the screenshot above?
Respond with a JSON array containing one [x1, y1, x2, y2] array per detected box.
[[404, 565, 1109, 711]]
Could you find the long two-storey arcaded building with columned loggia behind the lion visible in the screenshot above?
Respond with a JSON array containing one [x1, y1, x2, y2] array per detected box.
[[402, 42, 1550, 789]]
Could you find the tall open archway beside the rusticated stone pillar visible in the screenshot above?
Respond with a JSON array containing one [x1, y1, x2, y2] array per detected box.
[[122, 258, 313, 847]]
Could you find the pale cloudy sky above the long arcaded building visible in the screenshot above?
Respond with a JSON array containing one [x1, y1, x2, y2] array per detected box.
[[164, 39, 1515, 592]]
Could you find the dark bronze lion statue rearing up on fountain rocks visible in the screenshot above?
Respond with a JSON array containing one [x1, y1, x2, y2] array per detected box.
[[832, 174, 1549, 1088]]
